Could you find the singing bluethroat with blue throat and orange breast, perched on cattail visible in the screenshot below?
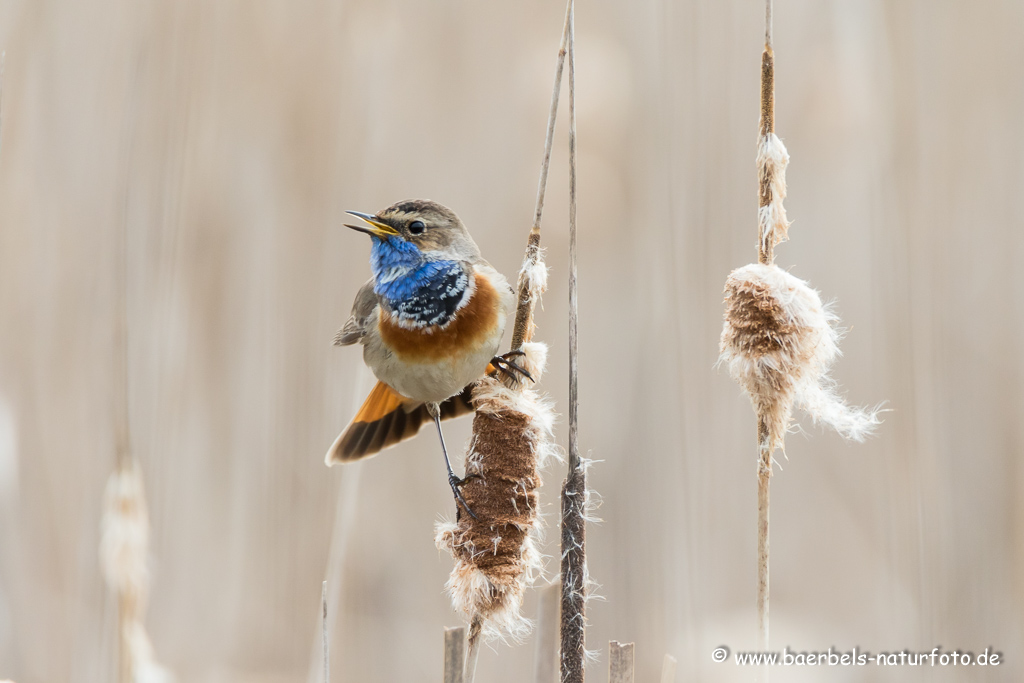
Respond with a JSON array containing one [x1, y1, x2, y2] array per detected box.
[[326, 200, 529, 517]]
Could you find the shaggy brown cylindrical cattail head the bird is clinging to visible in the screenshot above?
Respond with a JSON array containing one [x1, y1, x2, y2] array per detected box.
[[436, 343, 557, 641]]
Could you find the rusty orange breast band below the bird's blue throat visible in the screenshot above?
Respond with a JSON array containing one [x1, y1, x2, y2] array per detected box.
[[377, 274, 500, 362]]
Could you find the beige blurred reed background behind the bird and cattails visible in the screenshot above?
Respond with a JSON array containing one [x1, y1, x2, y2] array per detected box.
[[0, 0, 1024, 683]]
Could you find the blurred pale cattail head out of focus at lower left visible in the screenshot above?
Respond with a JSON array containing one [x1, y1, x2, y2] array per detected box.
[[99, 460, 173, 683]]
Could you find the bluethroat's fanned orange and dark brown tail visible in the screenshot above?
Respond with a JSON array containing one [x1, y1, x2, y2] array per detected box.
[[325, 382, 473, 465]]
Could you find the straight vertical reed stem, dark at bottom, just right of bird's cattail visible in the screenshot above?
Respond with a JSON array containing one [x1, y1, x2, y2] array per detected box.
[[560, 0, 587, 683]]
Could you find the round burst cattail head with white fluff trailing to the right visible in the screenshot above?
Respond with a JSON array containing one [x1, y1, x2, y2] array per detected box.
[[719, 263, 879, 451]]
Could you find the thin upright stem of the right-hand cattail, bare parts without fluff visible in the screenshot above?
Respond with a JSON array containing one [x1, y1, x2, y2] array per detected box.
[[758, 0, 775, 655]]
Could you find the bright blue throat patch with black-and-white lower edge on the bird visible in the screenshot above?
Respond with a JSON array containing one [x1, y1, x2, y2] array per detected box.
[[370, 237, 469, 327]]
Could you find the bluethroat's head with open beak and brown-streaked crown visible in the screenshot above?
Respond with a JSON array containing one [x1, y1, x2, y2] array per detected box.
[[345, 200, 480, 261]]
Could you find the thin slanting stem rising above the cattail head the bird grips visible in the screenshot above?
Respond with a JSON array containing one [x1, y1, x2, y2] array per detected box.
[[512, 2, 572, 351]]
